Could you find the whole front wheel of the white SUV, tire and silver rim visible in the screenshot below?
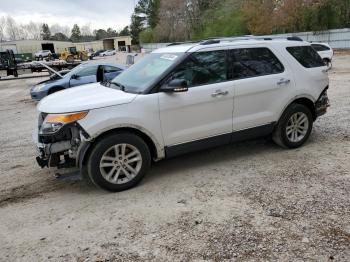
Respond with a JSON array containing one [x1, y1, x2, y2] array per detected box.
[[87, 133, 151, 192]]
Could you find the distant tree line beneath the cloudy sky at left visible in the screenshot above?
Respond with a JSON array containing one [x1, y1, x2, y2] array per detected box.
[[0, 16, 130, 42]]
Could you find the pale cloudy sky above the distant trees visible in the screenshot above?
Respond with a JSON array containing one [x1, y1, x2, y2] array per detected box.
[[0, 0, 137, 31]]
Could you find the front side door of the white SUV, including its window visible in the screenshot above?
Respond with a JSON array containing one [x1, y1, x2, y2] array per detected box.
[[159, 50, 233, 147]]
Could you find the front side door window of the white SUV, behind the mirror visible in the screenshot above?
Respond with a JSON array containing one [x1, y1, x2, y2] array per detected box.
[[172, 50, 227, 87]]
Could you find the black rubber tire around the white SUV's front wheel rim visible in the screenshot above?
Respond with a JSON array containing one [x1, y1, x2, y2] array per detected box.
[[87, 132, 151, 192]]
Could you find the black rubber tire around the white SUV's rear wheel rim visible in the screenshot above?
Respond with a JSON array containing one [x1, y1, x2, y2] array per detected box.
[[272, 104, 313, 148]]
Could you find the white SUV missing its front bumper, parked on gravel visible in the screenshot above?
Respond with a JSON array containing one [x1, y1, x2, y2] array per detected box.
[[35, 39, 329, 191]]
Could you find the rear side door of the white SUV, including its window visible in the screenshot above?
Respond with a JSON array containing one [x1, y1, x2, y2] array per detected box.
[[230, 46, 294, 131]]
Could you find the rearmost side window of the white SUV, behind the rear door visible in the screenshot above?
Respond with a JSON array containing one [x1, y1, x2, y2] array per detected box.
[[287, 46, 325, 68]]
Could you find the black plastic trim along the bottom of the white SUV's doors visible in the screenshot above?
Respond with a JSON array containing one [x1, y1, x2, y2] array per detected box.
[[165, 122, 276, 158]]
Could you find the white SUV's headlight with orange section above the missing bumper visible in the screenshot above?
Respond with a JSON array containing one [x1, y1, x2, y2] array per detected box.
[[39, 111, 88, 135]]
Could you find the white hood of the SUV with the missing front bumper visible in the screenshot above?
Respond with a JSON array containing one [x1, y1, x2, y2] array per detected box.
[[38, 83, 137, 113]]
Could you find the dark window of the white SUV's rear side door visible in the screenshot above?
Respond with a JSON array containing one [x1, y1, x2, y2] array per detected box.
[[230, 47, 284, 80]]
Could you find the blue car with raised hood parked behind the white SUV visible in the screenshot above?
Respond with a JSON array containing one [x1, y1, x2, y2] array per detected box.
[[30, 63, 126, 101]]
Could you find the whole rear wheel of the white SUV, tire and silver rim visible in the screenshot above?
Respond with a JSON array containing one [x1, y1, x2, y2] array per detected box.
[[272, 104, 313, 148]]
